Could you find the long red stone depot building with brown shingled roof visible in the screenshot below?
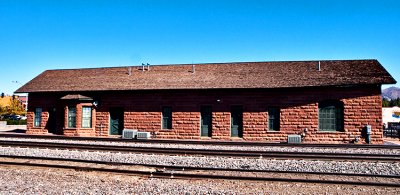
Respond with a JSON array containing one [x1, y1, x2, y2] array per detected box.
[[16, 60, 396, 143]]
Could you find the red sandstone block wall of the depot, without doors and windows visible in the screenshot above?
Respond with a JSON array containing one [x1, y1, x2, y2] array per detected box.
[[28, 86, 383, 143]]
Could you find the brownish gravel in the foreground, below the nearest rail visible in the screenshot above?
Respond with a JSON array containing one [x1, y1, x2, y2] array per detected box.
[[0, 166, 398, 195]]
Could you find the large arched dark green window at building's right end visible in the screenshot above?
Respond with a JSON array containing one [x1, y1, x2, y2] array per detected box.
[[318, 101, 344, 131]]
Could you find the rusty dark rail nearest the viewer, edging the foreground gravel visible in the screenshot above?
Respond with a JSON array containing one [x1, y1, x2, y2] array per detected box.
[[0, 156, 400, 187]]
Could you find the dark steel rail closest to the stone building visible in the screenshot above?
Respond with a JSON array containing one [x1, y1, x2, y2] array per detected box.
[[0, 133, 400, 149]]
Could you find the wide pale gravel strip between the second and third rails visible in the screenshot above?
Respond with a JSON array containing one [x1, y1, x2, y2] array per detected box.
[[0, 147, 400, 175]]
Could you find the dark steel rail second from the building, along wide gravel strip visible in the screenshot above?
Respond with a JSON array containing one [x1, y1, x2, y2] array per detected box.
[[0, 141, 400, 162]]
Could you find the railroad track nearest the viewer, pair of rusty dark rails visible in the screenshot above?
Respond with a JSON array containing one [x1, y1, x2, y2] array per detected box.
[[0, 156, 400, 188]]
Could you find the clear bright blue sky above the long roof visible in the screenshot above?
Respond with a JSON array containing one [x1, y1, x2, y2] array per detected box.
[[0, 0, 400, 94]]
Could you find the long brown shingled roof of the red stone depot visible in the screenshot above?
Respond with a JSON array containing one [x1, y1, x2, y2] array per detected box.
[[16, 60, 396, 93]]
